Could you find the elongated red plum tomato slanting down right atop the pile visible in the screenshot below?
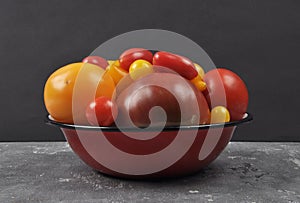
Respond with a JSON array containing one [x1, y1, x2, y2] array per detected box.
[[153, 51, 198, 80]]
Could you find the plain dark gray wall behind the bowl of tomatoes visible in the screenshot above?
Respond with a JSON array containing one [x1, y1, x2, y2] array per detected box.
[[0, 0, 300, 141]]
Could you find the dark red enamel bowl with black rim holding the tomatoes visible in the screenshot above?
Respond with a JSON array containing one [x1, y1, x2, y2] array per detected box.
[[47, 113, 253, 179]]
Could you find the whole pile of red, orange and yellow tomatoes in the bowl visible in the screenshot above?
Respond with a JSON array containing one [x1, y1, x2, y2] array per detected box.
[[44, 48, 248, 127]]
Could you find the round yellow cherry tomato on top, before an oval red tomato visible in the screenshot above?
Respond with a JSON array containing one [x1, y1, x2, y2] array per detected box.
[[129, 59, 153, 80]]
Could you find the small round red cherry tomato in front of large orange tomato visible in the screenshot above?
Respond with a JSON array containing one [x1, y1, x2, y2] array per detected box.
[[86, 96, 118, 126]]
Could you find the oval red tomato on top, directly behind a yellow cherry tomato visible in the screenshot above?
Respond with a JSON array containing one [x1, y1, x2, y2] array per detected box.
[[119, 48, 153, 71]]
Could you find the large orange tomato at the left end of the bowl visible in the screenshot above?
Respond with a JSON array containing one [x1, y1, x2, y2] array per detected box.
[[44, 63, 115, 124]]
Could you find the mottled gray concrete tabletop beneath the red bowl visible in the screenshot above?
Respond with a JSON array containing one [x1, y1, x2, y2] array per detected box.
[[0, 142, 300, 203]]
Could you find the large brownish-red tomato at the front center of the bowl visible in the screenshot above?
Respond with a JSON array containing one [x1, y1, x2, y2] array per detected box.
[[117, 73, 210, 127]]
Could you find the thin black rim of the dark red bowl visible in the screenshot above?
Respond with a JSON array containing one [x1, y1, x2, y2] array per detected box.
[[45, 112, 253, 132]]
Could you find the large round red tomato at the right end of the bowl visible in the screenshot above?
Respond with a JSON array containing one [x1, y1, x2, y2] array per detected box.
[[204, 68, 248, 120]]
